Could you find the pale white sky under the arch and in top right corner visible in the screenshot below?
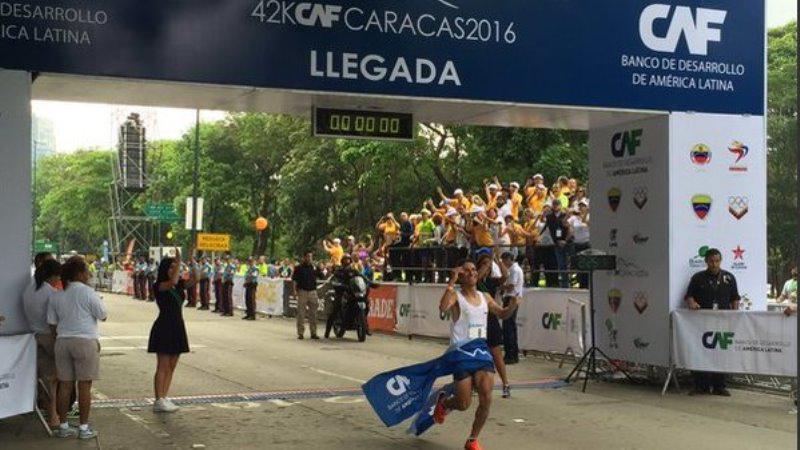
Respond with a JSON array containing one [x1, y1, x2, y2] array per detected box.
[[32, 0, 797, 153]]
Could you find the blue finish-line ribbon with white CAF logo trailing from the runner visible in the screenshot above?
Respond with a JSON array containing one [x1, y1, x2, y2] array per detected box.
[[361, 339, 494, 436]]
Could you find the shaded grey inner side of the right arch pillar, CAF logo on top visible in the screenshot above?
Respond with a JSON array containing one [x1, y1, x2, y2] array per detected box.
[[589, 116, 670, 366]]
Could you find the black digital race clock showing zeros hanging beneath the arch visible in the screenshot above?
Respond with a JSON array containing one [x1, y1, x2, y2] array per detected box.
[[314, 108, 414, 141]]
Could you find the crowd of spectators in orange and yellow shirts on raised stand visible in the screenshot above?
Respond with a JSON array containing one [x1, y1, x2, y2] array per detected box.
[[322, 174, 590, 287]]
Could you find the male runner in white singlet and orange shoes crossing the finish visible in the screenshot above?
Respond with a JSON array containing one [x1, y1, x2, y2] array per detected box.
[[434, 261, 519, 450]]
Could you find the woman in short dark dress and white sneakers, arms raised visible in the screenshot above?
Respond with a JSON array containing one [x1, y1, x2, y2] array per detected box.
[[147, 258, 196, 412]]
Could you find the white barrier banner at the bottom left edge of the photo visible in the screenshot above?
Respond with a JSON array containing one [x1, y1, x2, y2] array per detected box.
[[0, 334, 36, 419]]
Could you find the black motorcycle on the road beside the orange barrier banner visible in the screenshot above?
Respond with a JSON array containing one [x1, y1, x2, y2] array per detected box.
[[331, 275, 371, 342]]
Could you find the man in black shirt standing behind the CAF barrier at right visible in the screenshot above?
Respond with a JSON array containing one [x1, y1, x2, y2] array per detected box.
[[685, 248, 741, 397]]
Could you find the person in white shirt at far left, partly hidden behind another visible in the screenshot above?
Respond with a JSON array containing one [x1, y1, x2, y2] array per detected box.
[[22, 259, 61, 428]]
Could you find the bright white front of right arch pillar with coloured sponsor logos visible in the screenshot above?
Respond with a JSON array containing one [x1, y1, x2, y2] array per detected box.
[[669, 113, 767, 311]]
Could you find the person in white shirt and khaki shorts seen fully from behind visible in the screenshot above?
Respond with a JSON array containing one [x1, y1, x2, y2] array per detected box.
[[47, 257, 107, 439]]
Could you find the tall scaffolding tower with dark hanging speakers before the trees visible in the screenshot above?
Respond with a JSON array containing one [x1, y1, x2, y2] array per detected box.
[[108, 113, 157, 260]]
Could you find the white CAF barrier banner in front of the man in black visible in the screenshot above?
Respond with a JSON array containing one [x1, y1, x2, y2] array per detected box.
[[672, 309, 797, 377]]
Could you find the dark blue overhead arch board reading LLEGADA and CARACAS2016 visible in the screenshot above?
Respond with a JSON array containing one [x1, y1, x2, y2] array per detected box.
[[0, 0, 765, 114]]
